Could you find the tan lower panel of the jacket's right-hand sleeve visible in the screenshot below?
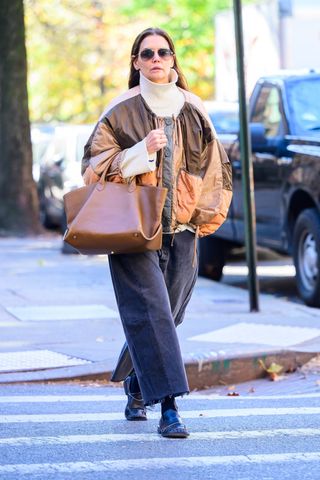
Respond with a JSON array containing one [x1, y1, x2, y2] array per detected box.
[[191, 137, 232, 237]]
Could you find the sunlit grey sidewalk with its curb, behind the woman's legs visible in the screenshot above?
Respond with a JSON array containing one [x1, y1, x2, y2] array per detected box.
[[0, 235, 320, 389]]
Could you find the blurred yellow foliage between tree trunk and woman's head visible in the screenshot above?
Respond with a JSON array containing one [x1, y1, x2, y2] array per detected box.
[[25, 0, 136, 123]]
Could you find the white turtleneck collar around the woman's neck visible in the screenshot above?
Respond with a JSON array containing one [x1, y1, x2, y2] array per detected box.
[[140, 68, 185, 116]]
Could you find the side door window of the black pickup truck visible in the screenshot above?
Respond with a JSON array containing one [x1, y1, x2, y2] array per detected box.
[[251, 86, 283, 138]]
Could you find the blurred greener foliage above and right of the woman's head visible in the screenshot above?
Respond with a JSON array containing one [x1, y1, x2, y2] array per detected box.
[[123, 0, 232, 100]]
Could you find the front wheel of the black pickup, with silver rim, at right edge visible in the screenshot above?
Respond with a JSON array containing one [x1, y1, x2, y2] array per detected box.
[[293, 208, 320, 307]]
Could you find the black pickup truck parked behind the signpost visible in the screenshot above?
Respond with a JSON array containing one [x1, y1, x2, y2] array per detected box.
[[199, 71, 320, 307]]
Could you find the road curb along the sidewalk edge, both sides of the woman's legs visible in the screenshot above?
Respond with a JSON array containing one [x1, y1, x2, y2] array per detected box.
[[0, 350, 318, 390]]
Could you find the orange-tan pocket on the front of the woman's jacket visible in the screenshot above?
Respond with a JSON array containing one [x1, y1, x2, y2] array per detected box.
[[176, 169, 202, 223]]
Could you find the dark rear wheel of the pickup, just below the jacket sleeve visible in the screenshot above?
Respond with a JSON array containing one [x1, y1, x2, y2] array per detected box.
[[199, 237, 227, 282]]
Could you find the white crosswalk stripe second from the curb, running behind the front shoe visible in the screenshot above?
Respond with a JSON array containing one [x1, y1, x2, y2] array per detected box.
[[0, 407, 320, 424]]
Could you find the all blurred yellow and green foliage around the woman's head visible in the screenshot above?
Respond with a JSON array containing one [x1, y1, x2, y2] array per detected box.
[[25, 0, 232, 123]]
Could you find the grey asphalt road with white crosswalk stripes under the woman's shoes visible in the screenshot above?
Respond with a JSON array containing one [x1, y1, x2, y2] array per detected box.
[[0, 380, 320, 480]]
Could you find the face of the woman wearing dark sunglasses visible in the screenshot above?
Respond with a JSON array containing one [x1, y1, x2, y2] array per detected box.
[[133, 35, 174, 83]]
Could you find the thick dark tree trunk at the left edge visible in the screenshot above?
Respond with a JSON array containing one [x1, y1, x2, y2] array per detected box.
[[0, 0, 41, 235]]
